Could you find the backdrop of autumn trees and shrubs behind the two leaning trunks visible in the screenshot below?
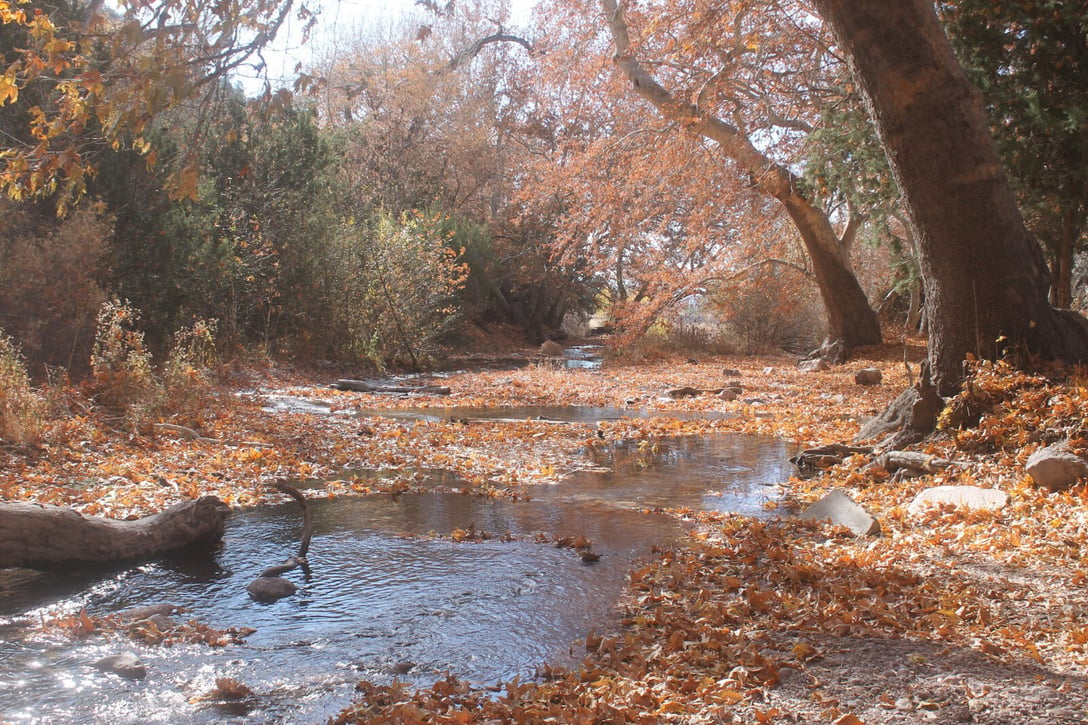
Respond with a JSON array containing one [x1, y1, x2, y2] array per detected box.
[[0, 2, 1088, 396]]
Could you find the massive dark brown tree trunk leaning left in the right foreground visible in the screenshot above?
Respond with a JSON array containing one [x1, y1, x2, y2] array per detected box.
[[815, 0, 1088, 394]]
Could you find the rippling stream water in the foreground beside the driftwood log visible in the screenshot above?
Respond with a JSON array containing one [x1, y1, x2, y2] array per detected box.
[[0, 426, 791, 725]]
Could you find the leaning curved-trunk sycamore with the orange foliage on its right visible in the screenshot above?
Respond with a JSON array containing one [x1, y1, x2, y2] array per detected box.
[[578, 0, 881, 360]]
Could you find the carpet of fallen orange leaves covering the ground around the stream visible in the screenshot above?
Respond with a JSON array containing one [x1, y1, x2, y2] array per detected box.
[[6, 335, 1088, 723]]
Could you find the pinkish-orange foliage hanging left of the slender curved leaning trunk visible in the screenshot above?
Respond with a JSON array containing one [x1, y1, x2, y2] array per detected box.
[[516, 3, 820, 342]]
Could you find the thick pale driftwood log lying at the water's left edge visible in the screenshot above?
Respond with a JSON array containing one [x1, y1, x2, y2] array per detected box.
[[0, 496, 231, 569]]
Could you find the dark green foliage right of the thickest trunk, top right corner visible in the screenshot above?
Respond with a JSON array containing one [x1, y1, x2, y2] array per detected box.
[[940, 0, 1088, 307]]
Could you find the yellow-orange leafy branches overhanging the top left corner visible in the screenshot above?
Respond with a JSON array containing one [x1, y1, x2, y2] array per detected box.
[[0, 0, 313, 201]]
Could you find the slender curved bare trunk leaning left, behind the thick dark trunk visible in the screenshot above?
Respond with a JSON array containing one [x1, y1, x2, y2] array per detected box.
[[601, 0, 881, 353]]
